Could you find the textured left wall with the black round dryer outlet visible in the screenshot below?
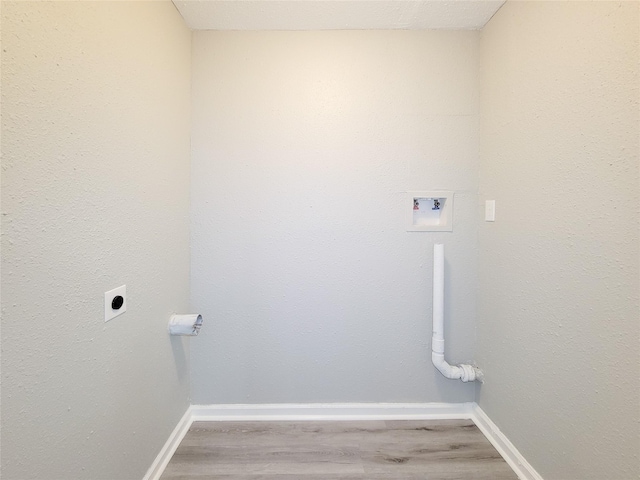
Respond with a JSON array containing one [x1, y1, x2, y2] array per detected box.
[[2, 1, 191, 480]]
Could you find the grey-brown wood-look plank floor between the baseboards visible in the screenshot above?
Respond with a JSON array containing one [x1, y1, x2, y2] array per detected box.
[[162, 420, 517, 480]]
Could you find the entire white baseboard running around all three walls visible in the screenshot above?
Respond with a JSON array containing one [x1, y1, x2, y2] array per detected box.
[[143, 402, 543, 480]]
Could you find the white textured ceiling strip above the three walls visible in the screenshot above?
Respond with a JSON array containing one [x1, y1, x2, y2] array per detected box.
[[173, 0, 505, 30]]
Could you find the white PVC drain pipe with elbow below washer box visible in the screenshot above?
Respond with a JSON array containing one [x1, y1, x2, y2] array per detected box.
[[431, 243, 482, 382]]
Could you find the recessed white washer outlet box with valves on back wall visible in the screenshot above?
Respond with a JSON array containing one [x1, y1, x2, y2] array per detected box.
[[405, 190, 453, 232]]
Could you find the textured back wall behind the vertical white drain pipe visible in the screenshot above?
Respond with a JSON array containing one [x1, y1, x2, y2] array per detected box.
[[191, 31, 478, 403]]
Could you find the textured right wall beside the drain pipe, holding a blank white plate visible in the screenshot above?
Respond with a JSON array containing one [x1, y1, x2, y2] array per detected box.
[[477, 2, 640, 480]]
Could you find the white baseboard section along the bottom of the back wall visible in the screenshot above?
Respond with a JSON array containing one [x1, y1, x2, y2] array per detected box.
[[191, 402, 475, 422]]
